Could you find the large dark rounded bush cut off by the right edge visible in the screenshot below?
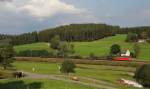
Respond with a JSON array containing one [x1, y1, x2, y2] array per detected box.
[[134, 64, 150, 88]]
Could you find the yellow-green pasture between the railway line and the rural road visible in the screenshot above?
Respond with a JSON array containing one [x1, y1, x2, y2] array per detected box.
[[13, 62, 143, 89]]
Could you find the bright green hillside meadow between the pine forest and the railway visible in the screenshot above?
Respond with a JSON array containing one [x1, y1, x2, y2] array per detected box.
[[15, 35, 150, 60]]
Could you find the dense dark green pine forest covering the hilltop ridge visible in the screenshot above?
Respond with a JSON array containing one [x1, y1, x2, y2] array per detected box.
[[0, 24, 150, 45]]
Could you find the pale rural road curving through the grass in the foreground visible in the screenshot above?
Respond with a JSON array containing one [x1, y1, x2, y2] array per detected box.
[[24, 72, 118, 89]]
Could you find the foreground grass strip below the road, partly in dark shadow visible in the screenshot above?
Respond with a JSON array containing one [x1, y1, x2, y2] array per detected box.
[[0, 79, 98, 89]]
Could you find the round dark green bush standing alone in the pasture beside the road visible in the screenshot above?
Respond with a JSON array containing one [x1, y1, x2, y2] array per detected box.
[[60, 60, 76, 74]]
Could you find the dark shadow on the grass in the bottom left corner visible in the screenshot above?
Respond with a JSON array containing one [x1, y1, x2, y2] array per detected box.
[[0, 81, 42, 89]]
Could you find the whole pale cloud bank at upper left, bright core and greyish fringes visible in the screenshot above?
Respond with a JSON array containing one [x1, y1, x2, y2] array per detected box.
[[0, 0, 97, 20]]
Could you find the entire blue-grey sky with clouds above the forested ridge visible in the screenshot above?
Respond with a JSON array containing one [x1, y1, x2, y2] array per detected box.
[[0, 0, 150, 34]]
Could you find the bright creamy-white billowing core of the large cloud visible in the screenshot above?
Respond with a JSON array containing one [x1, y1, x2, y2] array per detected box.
[[20, 0, 82, 18]]
